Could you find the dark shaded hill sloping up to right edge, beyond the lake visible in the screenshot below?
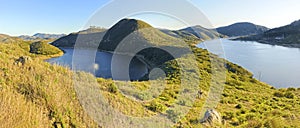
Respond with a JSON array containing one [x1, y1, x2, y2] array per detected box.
[[239, 20, 300, 48]]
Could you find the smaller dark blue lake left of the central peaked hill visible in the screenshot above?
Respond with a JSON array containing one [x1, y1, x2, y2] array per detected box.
[[46, 48, 148, 80]]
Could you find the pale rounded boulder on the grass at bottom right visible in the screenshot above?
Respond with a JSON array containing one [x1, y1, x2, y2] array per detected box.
[[201, 109, 222, 126]]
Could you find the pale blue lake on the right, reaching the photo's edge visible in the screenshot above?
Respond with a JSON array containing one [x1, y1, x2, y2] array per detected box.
[[198, 39, 300, 88]]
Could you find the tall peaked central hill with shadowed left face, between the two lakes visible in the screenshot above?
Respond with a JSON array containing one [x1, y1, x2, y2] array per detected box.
[[98, 19, 192, 70]]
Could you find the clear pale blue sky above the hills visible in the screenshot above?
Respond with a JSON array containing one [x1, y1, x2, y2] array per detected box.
[[0, 0, 300, 36]]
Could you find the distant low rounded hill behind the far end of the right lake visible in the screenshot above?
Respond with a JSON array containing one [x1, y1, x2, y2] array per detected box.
[[216, 22, 269, 37]]
